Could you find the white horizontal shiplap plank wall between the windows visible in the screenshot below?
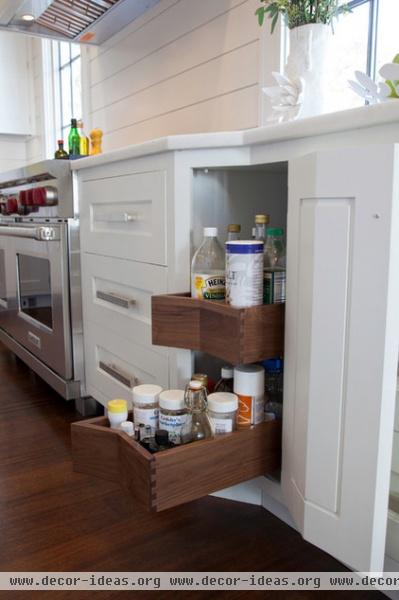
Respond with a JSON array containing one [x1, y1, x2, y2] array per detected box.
[[84, 0, 260, 150]]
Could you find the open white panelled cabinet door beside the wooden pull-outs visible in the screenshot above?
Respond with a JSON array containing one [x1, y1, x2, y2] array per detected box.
[[282, 144, 399, 571]]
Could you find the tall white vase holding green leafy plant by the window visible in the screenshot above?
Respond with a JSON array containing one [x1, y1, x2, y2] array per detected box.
[[285, 23, 332, 117]]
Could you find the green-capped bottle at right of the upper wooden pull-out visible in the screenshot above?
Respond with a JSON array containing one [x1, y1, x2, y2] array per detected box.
[[263, 227, 286, 304]]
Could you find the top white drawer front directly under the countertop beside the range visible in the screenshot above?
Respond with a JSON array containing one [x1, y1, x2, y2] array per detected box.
[[79, 171, 167, 265]]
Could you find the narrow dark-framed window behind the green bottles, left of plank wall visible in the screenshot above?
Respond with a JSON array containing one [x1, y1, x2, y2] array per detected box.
[[52, 42, 82, 140]]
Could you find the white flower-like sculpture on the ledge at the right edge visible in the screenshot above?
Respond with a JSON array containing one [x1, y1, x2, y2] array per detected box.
[[348, 63, 399, 104]]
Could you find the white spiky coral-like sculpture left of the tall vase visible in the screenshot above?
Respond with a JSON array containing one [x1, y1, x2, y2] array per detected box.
[[262, 71, 305, 120]]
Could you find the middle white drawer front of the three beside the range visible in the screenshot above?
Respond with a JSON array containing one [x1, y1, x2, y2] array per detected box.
[[82, 254, 167, 355]]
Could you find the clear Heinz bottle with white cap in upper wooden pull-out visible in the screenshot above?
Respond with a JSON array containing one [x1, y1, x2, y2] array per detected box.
[[191, 227, 226, 300]]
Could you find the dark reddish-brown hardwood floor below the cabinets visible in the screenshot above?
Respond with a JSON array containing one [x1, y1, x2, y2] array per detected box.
[[0, 346, 383, 600]]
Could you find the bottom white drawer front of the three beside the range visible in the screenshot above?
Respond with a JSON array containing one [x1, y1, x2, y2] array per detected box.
[[84, 321, 169, 402]]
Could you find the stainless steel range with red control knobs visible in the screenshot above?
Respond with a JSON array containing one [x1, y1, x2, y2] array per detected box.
[[0, 160, 84, 399]]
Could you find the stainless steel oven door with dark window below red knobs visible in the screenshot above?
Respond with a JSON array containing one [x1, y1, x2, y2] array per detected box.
[[0, 223, 73, 379]]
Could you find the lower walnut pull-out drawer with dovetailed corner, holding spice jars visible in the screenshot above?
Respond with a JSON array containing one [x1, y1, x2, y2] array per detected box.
[[72, 417, 281, 512]]
